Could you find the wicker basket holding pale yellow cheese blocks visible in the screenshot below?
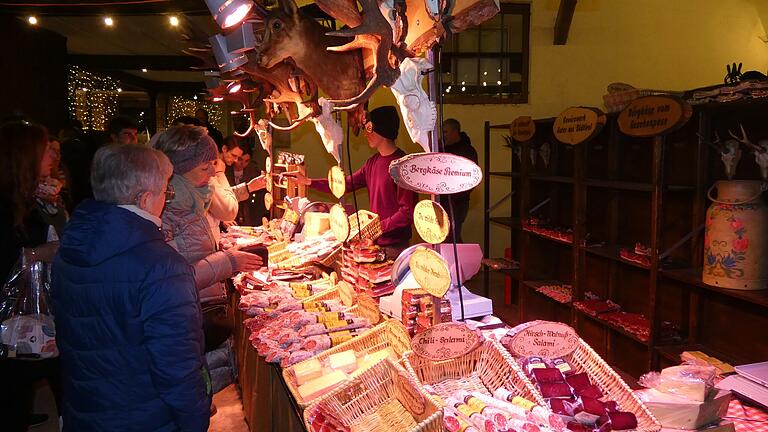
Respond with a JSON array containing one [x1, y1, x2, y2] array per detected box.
[[283, 319, 411, 408]]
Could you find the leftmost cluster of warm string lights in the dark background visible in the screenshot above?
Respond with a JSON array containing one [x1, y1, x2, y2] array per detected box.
[[67, 66, 120, 130]]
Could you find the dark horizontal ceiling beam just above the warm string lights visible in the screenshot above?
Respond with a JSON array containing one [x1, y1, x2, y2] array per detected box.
[[69, 54, 202, 72]]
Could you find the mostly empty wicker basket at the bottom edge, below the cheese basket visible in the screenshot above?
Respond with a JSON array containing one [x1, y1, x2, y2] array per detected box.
[[304, 360, 443, 432]]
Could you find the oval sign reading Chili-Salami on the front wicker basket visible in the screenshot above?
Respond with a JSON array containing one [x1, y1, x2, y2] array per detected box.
[[411, 323, 482, 361]]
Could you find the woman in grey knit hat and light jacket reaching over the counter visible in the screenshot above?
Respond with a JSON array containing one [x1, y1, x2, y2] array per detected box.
[[152, 125, 265, 392]]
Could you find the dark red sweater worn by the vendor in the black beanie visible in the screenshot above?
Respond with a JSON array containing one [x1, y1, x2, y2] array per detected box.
[[310, 148, 418, 246]]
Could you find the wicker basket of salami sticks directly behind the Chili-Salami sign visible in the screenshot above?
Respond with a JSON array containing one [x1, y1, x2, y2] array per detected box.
[[403, 340, 548, 407]]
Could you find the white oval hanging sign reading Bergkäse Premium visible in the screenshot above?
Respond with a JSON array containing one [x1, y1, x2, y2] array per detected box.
[[389, 153, 483, 195]]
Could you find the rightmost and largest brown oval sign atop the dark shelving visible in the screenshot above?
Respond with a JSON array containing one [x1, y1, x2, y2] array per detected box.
[[618, 96, 693, 138]]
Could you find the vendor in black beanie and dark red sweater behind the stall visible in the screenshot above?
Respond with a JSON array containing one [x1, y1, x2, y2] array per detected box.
[[293, 106, 418, 259]]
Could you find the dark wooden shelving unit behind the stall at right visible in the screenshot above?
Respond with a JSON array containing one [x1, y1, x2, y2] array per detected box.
[[485, 96, 768, 376]]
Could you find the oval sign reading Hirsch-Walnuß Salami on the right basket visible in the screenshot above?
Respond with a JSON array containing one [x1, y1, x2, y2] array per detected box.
[[507, 321, 579, 358]]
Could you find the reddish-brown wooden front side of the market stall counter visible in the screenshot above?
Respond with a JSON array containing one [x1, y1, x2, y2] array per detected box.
[[231, 293, 306, 432]]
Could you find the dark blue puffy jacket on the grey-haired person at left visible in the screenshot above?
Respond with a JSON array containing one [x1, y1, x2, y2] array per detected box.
[[52, 201, 211, 432]]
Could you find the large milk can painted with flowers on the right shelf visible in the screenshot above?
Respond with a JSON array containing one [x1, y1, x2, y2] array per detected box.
[[702, 180, 768, 290]]
